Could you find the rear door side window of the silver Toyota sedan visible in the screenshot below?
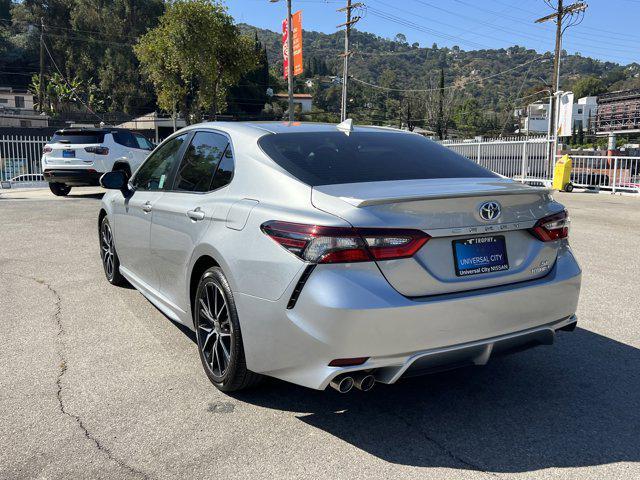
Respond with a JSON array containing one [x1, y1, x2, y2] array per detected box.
[[174, 132, 229, 192]]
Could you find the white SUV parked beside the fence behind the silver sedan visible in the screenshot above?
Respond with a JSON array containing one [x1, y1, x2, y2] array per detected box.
[[42, 128, 154, 196]]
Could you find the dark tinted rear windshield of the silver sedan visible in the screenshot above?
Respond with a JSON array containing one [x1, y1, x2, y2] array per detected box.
[[258, 131, 497, 186]]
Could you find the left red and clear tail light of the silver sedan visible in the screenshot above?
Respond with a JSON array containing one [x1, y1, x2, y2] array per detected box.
[[261, 221, 431, 263]]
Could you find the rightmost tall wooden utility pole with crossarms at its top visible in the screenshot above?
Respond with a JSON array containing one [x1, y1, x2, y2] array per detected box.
[[535, 0, 588, 169]]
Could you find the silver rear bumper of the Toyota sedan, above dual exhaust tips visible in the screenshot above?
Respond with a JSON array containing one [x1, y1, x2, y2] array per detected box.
[[235, 247, 581, 389]]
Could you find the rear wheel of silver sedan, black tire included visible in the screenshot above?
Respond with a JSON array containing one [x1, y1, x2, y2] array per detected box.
[[198, 267, 262, 392]]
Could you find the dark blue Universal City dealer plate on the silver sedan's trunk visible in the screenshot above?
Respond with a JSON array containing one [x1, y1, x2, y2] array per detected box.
[[451, 235, 509, 277]]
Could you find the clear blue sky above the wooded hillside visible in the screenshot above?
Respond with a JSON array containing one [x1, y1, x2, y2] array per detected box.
[[223, 0, 640, 64]]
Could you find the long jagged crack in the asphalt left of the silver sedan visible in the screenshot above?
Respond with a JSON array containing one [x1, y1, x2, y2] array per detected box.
[[1, 273, 152, 480]]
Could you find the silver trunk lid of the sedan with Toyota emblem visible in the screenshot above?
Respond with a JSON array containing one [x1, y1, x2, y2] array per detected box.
[[312, 178, 562, 297]]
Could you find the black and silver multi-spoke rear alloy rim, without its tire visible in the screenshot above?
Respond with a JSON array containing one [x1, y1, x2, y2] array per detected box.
[[196, 281, 233, 380]]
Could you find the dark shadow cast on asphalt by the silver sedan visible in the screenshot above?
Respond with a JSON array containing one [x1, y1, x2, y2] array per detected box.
[[233, 328, 640, 473]]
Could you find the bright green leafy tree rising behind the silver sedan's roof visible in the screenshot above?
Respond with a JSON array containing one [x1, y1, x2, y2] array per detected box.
[[134, 0, 258, 122]]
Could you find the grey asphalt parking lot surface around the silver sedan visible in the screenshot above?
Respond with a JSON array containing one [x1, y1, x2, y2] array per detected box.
[[0, 189, 640, 479]]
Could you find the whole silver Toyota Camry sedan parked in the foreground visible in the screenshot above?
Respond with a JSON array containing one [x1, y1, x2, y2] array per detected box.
[[98, 121, 581, 392]]
